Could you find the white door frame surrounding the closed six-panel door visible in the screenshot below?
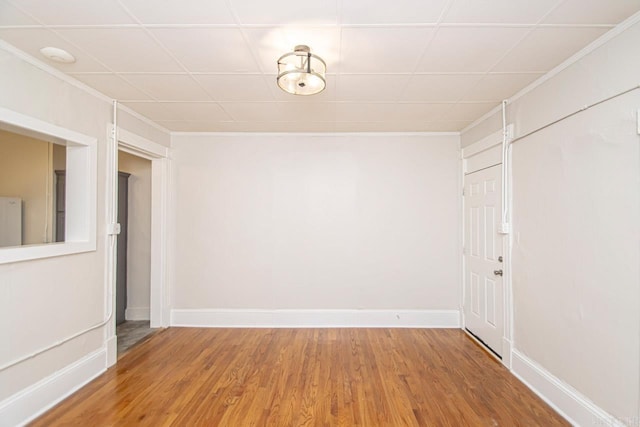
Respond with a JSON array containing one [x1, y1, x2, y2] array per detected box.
[[460, 130, 513, 368]]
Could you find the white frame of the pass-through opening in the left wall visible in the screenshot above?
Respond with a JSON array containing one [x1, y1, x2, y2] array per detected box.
[[0, 107, 97, 264]]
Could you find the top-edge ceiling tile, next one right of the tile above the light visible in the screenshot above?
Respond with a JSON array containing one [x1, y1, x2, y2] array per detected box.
[[341, 0, 448, 24]]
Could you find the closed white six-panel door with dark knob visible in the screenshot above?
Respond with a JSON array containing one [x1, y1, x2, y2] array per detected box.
[[464, 165, 504, 356]]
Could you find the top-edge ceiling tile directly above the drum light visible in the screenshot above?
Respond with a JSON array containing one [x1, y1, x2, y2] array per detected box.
[[231, 0, 338, 25]]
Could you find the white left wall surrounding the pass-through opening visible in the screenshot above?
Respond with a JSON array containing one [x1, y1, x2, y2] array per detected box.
[[0, 42, 169, 425]]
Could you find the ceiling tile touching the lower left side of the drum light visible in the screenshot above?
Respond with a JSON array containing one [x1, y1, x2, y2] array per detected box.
[[193, 74, 275, 101]]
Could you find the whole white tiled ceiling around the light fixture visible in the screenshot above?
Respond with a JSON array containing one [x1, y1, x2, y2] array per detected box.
[[0, 0, 640, 132]]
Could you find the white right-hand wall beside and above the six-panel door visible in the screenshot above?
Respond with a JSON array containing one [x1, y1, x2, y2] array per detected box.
[[462, 17, 640, 423]]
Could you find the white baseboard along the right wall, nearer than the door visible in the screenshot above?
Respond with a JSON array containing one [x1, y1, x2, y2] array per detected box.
[[511, 350, 625, 427]]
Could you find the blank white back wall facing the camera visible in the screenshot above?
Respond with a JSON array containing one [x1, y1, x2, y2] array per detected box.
[[172, 134, 461, 322]]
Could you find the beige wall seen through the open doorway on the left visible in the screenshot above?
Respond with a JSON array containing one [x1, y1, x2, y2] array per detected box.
[[118, 151, 151, 320]]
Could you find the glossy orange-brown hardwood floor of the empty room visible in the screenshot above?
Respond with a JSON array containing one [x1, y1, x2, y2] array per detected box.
[[32, 328, 569, 427]]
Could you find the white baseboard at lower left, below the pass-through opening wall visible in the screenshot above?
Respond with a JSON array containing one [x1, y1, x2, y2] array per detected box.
[[0, 347, 106, 426]]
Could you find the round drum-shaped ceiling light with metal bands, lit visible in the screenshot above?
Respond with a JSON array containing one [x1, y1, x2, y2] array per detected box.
[[278, 45, 327, 95]]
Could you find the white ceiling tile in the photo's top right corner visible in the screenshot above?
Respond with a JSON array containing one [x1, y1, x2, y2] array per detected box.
[[543, 0, 640, 24]]
